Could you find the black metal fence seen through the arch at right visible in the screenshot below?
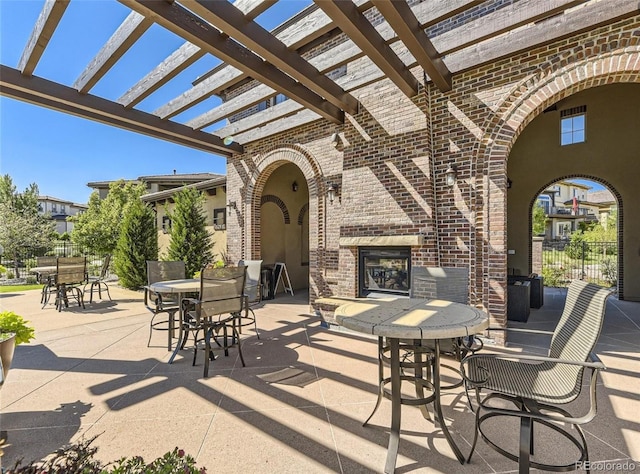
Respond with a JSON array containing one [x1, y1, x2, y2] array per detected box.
[[542, 240, 618, 287]]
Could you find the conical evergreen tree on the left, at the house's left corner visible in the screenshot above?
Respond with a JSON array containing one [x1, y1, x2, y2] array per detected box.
[[114, 199, 158, 289]]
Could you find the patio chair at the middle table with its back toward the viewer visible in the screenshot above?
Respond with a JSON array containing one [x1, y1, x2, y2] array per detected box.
[[182, 266, 248, 377]]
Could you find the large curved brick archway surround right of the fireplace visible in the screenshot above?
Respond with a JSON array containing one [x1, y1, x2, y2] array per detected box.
[[474, 43, 640, 325]]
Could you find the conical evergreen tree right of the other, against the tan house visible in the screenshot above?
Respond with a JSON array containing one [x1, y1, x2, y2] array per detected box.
[[167, 188, 213, 278]]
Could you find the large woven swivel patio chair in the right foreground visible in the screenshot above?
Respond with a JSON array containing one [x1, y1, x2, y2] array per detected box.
[[461, 280, 612, 474]]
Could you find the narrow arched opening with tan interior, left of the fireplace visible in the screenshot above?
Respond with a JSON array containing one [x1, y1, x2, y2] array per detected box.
[[259, 162, 309, 292]]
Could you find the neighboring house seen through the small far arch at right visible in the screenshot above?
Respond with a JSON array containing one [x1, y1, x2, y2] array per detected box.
[[538, 181, 613, 240]]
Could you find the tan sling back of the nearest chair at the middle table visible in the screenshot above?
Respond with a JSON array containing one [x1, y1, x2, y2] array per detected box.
[[197, 266, 247, 318]]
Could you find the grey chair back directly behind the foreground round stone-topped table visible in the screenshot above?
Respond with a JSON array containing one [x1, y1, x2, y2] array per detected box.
[[409, 267, 469, 304]]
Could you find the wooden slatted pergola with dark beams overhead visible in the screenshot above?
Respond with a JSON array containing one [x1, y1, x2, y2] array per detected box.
[[0, 0, 638, 156]]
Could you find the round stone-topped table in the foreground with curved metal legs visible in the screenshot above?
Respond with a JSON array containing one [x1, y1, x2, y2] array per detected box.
[[334, 298, 489, 473]]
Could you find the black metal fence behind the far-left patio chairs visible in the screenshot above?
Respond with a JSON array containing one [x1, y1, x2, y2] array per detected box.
[[0, 244, 104, 280]]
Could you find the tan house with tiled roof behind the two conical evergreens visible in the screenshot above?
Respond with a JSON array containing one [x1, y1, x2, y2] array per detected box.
[[139, 173, 231, 259]]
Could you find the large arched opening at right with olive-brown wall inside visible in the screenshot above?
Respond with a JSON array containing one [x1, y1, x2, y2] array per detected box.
[[507, 84, 640, 299]]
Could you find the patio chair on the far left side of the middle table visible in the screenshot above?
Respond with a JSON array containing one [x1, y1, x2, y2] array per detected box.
[[144, 260, 186, 351]]
